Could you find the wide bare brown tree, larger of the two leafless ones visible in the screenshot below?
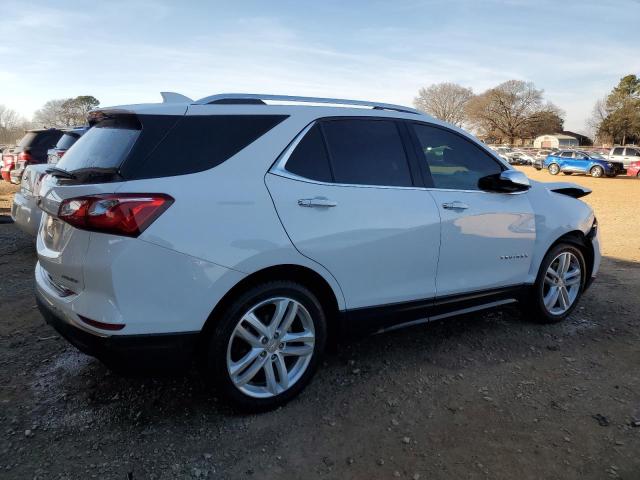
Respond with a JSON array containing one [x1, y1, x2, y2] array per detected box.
[[467, 80, 564, 144]]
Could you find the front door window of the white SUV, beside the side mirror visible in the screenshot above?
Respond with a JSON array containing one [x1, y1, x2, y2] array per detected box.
[[413, 124, 504, 190]]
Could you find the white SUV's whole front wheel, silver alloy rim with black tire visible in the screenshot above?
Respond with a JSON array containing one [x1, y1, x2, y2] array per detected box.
[[523, 244, 586, 323]]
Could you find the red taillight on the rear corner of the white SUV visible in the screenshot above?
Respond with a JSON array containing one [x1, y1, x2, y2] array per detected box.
[[58, 193, 173, 237]]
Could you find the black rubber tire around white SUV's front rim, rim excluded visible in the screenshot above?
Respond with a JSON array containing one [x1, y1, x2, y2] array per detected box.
[[521, 243, 587, 323]]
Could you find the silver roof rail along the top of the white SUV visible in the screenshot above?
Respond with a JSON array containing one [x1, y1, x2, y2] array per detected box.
[[194, 93, 424, 115]]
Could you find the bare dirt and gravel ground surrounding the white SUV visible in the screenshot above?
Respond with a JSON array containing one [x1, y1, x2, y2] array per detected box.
[[0, 169, 640, 479]]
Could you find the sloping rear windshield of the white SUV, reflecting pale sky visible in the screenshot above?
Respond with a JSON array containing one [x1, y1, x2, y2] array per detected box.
[[57, 115, 142, 172]]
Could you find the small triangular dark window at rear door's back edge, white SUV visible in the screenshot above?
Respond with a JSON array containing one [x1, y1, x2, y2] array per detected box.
[[287, 124, 333, 182]]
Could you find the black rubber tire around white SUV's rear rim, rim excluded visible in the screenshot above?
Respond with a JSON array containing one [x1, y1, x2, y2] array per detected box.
[[205, 281, 327, 412]]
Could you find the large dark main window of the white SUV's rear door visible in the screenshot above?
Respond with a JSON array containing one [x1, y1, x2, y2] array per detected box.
[[321, 119, 413, 187]]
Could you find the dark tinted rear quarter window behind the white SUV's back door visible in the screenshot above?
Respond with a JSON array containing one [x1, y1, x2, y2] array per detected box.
[[127, 115, 287, 179]]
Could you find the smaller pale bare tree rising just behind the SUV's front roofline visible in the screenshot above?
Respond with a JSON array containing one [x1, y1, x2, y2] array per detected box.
[[413, 83, 473, 126]]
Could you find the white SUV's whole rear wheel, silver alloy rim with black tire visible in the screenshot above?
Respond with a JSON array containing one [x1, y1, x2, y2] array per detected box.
[[209, 282, 326, 411]]
